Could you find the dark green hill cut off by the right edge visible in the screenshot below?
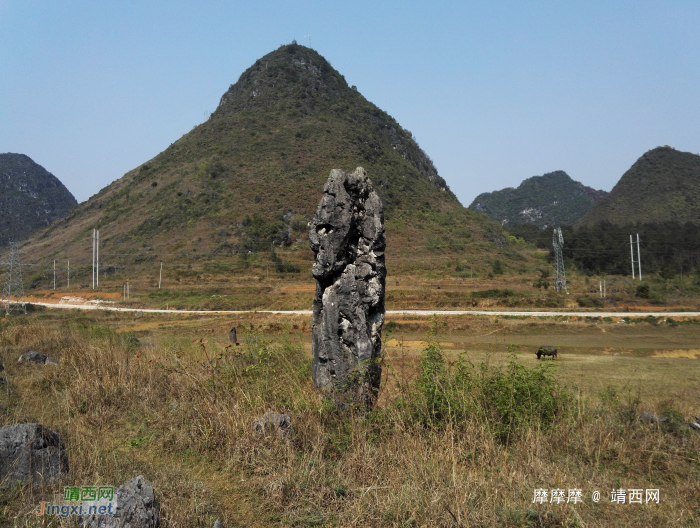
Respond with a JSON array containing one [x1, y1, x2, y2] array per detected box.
[[580, 146, 700, 225]]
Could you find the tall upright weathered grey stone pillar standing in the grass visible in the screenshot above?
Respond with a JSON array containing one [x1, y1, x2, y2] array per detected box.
[[309, 167, 386, 409]]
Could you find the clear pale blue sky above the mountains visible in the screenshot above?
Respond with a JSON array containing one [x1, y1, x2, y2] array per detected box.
[[0, 0, 700, 205]]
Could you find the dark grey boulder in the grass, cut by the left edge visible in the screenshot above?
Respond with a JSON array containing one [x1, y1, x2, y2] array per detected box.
[[0, 423, 68, 487]]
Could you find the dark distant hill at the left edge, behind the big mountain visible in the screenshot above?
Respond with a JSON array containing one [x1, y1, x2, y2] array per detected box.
[[0, 152, 78, 246]]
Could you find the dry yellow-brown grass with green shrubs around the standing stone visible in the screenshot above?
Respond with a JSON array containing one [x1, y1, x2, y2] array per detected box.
[[0, 313, 700, 528]]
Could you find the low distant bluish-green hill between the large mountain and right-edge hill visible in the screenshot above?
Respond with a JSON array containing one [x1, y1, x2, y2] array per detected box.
[[469, 171, 607, 228]]
